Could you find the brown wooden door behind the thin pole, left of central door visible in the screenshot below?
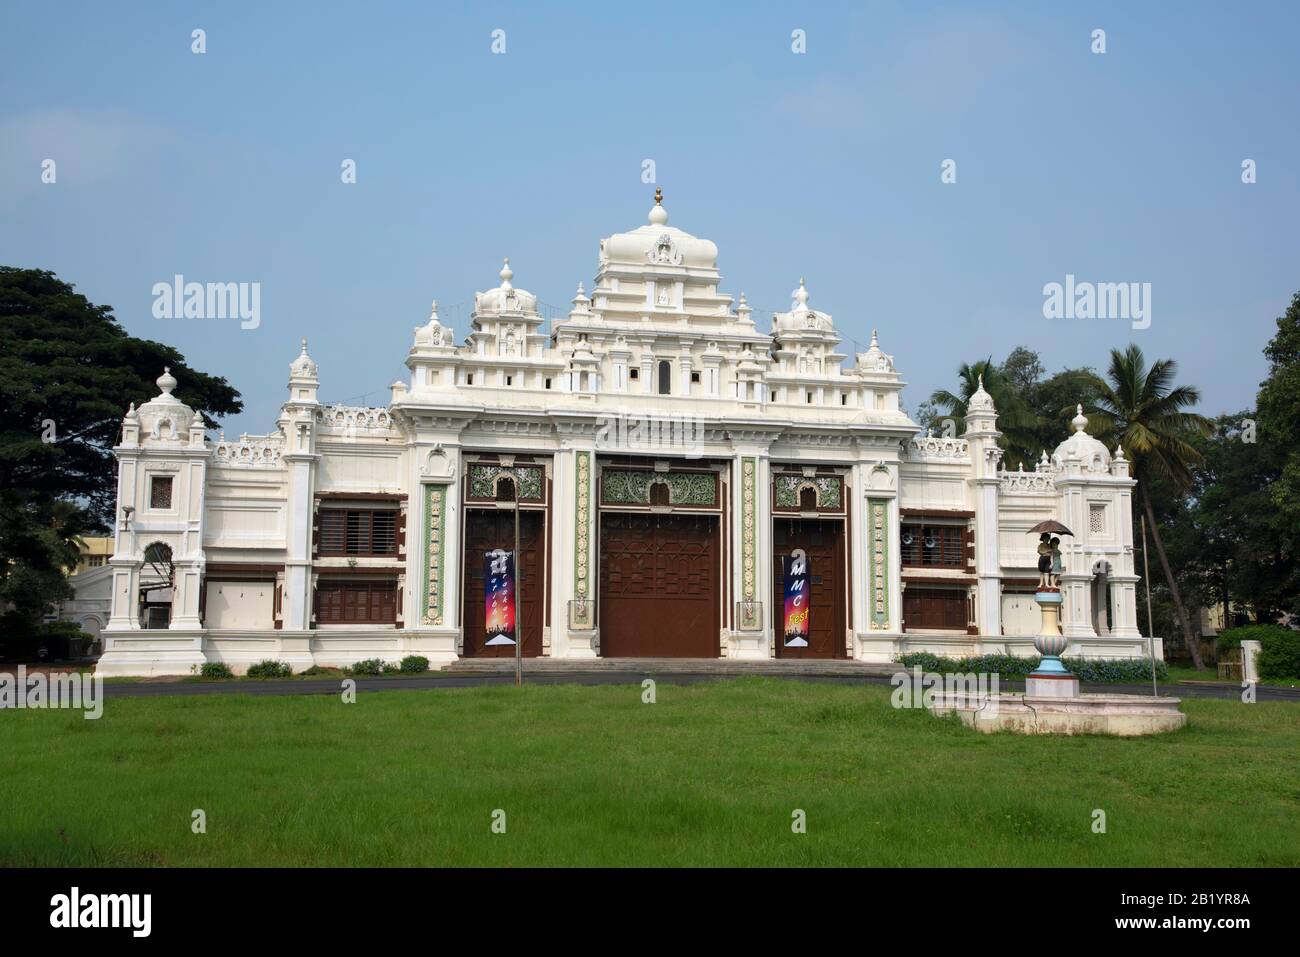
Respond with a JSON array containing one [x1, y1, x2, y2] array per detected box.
[[460, 508, 546, 658]]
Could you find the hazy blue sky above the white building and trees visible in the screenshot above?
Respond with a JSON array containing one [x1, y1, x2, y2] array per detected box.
[[0, 0, 1300, 433]]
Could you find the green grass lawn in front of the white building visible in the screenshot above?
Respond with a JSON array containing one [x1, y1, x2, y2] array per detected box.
[[0, 677, 1300, 866]]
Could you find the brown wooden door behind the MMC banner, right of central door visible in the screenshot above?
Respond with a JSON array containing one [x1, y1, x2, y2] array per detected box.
[[772, 516, 848, 658]]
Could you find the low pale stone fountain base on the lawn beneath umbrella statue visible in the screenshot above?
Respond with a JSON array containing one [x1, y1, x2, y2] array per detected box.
[[931, 679, 1187, 737]]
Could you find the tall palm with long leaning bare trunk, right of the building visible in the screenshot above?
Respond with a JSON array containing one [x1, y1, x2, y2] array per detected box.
[[1091, 345, 1213, 671]]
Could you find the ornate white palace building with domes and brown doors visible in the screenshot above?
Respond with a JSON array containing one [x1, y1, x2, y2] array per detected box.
[[99, 196, 1158, 675]]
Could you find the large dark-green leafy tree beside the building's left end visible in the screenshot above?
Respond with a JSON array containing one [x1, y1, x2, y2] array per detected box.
[[0, 267, 243, 647]]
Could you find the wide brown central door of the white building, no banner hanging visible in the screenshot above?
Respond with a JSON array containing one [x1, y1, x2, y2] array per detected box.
[[599, 514, 722, 658]]
